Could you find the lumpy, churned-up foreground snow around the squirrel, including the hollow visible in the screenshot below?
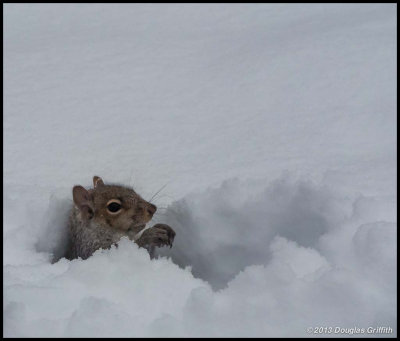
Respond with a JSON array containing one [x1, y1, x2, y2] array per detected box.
[[4, 176, 396, 337]]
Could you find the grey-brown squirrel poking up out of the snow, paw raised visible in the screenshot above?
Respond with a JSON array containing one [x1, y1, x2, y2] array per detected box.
[[65, 176, 175, 260]]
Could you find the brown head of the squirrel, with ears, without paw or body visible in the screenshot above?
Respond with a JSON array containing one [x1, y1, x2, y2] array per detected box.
[[72, 176, 157, 233]]
